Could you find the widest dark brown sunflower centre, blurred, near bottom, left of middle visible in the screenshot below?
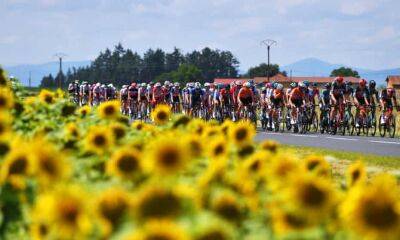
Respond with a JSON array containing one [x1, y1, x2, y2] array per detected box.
[[135, 185, 183, 219]]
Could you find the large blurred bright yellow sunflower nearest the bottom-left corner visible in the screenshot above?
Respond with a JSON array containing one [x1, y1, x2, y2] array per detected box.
[[32, 185, 91, 239]]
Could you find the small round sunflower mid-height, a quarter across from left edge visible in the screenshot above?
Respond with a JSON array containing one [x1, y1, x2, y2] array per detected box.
[[85, 127, 113, 154]]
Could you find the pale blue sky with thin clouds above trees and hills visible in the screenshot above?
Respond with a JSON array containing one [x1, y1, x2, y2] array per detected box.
[[0, 0, 400, 70]]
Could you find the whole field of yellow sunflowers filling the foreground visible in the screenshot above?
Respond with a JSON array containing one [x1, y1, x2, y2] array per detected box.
[[0, 69, 400, 240]]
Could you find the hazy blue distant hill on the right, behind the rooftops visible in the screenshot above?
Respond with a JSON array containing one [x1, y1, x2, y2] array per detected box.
[[282, 58, 400, 85]]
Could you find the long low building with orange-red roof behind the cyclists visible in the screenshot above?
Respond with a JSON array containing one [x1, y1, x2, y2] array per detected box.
[[214, 74, 360, 88]]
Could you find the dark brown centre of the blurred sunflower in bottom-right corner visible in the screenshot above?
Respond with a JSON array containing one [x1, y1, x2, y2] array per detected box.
[[363, 201, 400, 229]]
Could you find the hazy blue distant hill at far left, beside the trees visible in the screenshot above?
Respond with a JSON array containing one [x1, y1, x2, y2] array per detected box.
[[4, 61, 90, 86]]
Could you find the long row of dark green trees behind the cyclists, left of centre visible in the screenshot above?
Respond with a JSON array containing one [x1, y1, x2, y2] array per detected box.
[[41, 44, 239, 87]]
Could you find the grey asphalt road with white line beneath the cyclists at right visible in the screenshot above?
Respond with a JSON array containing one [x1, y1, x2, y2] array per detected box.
[[256, 131, 400, 157]]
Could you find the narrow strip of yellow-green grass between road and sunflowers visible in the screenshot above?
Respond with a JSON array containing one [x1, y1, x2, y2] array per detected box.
[[281, 145, 400, 172]]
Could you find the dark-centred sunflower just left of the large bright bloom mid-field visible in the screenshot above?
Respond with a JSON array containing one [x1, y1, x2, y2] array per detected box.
[[107, 148, 142, 179]]
